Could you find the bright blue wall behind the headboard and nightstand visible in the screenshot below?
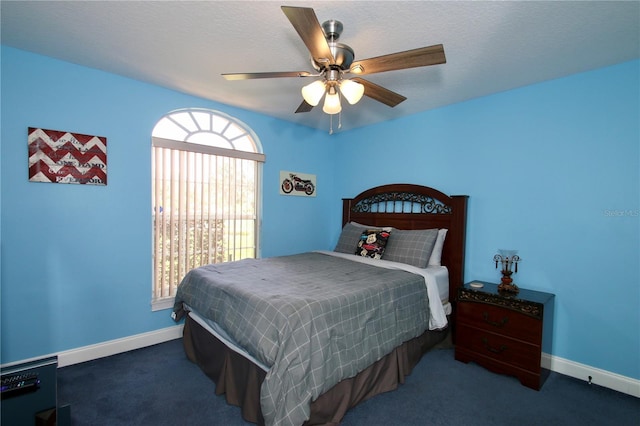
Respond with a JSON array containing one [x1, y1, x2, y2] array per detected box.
[[336, 61, 640, 379]]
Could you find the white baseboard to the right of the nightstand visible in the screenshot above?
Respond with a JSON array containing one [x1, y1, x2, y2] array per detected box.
[[542, 353, 640, 398]]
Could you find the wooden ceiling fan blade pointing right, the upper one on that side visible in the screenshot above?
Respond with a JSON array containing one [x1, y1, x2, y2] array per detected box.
[[350, 44, 447, 75]]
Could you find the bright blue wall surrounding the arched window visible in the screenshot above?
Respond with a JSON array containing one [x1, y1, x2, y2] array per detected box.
[[1, 46, 333, 363]]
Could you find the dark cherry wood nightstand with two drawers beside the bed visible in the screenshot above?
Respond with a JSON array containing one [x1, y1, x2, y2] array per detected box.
[[455, 281, 555, 390]]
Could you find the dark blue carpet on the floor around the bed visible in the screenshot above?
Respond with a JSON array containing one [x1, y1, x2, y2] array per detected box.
[[58, 339, 640, 426]]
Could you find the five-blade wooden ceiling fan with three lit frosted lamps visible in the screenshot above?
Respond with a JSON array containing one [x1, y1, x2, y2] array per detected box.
[[222, 6, 446, 118]]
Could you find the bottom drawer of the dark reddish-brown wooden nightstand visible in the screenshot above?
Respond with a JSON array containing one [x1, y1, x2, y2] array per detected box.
[[457, 323, 540, 373]]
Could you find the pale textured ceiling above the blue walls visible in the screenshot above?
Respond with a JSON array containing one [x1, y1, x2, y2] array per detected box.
[[0, 0, 640, 131]]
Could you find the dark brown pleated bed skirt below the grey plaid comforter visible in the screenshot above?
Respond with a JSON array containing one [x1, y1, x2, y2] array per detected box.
[[183, 315, 448, 425]]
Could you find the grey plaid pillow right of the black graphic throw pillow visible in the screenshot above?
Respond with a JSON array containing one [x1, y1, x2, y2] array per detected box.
[[383, 229, 438, 268]]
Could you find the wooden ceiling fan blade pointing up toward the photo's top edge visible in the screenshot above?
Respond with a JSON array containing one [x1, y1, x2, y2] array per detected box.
[[282, 6, 336, 65]]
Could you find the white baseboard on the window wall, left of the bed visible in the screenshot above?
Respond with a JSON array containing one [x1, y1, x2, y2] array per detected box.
[[57, 324, 184, 367]]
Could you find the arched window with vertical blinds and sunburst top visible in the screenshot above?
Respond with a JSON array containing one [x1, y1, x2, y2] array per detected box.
[[151, 108, 265, 310]]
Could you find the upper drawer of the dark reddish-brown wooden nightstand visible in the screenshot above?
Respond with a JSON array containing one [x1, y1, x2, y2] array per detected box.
[[458, 302, 542, 343]]
